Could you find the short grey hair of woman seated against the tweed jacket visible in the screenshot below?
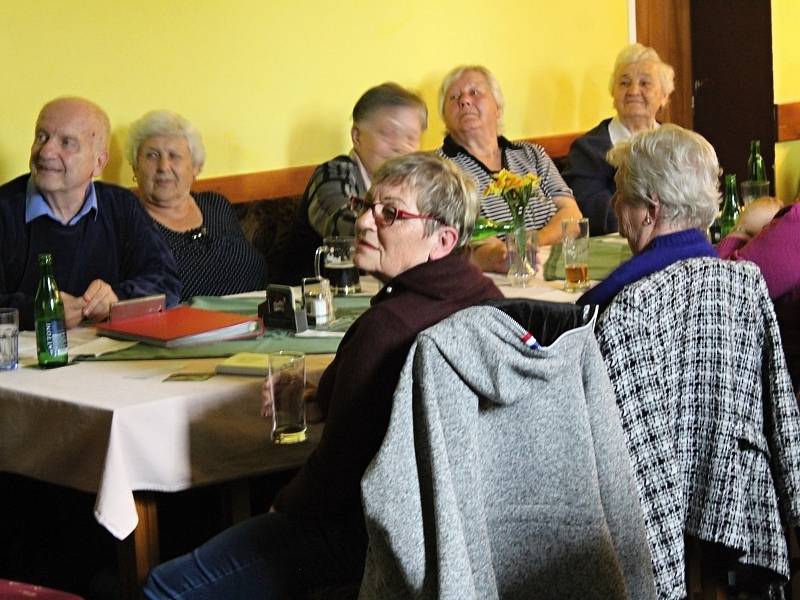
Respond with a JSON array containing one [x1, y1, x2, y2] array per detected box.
[[606, 123, 720, 229]]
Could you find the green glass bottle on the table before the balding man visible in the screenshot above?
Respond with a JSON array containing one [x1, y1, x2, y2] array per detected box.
[[33, 254, 68, 369]]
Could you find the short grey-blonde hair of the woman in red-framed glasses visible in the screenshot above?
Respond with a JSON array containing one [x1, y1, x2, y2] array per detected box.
[[372, 152, 480, 249]]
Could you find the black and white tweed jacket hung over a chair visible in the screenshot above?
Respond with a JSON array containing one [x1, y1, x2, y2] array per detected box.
[[597, 258, 800, 599]]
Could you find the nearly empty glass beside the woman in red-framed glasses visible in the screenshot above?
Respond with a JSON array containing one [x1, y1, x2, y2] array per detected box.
[[267, 350, 306, 444]]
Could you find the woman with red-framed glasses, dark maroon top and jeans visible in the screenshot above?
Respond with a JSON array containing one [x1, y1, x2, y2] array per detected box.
[[144, 153, 502, 599]]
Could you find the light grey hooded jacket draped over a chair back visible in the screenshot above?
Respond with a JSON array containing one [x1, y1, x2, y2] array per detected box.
[[361, 300, 655, 600]]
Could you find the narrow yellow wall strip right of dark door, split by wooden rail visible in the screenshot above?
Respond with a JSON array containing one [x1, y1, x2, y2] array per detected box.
[[772, 0, 800, 202]]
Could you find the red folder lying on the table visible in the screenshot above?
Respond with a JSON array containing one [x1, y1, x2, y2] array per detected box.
[[97, 306, 261, 348]]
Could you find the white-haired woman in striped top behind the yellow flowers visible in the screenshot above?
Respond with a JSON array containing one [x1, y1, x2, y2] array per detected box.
[[439, 65, 581, 273]]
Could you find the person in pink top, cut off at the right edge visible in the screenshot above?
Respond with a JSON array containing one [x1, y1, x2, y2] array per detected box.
[[717, 198, 800, 392]]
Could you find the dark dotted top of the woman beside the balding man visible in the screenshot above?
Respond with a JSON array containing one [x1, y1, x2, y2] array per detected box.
[[154, 192, 267, 300]]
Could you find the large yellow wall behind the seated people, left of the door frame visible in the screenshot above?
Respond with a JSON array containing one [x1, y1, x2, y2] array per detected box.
[[0, 0, 628, 184]]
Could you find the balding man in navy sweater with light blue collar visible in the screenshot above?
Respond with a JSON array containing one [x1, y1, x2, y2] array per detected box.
[[0, 97, 180, 329]]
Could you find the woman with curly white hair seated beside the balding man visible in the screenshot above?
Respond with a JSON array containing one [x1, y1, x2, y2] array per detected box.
[[127, 110, 266, 300]]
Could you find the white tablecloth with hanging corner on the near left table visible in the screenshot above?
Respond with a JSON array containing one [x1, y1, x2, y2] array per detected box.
[[0, 330, 330, 539]]
